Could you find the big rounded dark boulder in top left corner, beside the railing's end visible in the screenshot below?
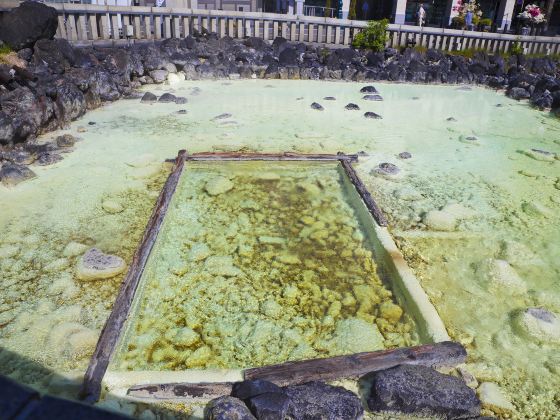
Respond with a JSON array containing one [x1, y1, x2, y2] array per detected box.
[[0, 1, 58, 51]]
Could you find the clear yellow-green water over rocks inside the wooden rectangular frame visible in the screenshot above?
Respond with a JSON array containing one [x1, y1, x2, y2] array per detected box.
[[110, 161, 428, 371]]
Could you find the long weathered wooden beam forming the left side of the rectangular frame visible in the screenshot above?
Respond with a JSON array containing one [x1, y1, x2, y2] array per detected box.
[[80, 150, 187, 403]]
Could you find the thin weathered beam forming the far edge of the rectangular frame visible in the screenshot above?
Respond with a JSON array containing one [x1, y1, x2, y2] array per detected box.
[[187, 152, 358, 162]]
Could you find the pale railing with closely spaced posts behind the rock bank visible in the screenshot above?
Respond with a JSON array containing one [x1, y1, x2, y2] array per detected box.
[[0, 0, 560, 54]]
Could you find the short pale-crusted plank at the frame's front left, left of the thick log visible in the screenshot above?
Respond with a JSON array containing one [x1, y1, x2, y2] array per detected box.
[[126, 382, 233, 400]]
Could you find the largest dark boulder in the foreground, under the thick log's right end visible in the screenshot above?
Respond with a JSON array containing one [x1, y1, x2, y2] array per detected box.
[[367, 365, 480, 419]]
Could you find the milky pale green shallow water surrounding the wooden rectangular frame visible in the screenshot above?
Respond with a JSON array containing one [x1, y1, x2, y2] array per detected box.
[[0, 81, 560, 418]]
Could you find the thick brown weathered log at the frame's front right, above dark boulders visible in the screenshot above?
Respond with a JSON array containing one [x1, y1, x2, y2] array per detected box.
[[243, 341, 467, 385]]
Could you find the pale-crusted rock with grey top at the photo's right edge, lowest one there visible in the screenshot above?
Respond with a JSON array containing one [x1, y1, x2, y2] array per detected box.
[[514, 308, 560, 343]]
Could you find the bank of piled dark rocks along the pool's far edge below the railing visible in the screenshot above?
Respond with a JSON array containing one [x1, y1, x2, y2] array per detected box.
[[0, 33, 560, 153]]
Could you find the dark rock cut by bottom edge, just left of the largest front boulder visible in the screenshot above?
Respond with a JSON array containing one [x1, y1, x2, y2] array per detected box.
[[284, 382, 364, 420]]
